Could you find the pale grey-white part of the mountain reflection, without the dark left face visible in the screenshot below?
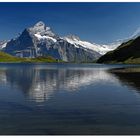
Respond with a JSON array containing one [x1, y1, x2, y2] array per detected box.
[[23, 69, 117, 102]]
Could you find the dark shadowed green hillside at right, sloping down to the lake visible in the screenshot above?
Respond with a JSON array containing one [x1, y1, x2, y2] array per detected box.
[[97, 37, 140, 63]]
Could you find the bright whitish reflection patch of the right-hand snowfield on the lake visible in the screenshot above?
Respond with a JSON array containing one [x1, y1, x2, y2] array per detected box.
[[62, 69, 117, 90]]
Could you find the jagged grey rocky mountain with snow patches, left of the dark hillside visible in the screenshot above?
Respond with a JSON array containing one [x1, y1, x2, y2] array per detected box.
[[0, 21, 105, 62]]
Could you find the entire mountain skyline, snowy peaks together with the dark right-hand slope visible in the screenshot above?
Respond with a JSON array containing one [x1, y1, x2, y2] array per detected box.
[[0, 21, 140, 63]]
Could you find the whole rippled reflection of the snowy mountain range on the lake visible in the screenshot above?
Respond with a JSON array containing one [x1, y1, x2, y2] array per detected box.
[[0, 66, 118, 102]]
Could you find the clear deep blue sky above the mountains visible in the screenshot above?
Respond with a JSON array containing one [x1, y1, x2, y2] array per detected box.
[[0, 3, 140, 43]]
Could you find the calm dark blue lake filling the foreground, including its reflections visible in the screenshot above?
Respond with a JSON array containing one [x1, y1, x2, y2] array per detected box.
[[0, 64, 140, 135]]
